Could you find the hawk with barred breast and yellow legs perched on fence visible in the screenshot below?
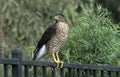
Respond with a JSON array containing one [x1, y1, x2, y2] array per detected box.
[[33, 14, 69, 68]]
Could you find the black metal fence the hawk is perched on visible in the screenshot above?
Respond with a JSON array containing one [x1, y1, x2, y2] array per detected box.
[[0, 51, 120, 77]]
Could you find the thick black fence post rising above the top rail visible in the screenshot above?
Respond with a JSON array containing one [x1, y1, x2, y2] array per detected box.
[[12, 50, 22, 77]]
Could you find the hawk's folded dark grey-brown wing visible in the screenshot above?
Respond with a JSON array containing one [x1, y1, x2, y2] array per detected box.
[[33, 24, 56, 59]]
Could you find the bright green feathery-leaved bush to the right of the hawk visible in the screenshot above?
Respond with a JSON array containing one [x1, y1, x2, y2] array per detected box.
[[61, 6, 120, 65]]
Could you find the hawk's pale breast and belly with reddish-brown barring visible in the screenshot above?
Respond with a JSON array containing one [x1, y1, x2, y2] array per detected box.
[[47, 22, 69, 52]]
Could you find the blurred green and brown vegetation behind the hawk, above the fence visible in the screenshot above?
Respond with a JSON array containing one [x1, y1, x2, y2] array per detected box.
[[0, 0, 120, 76]]
